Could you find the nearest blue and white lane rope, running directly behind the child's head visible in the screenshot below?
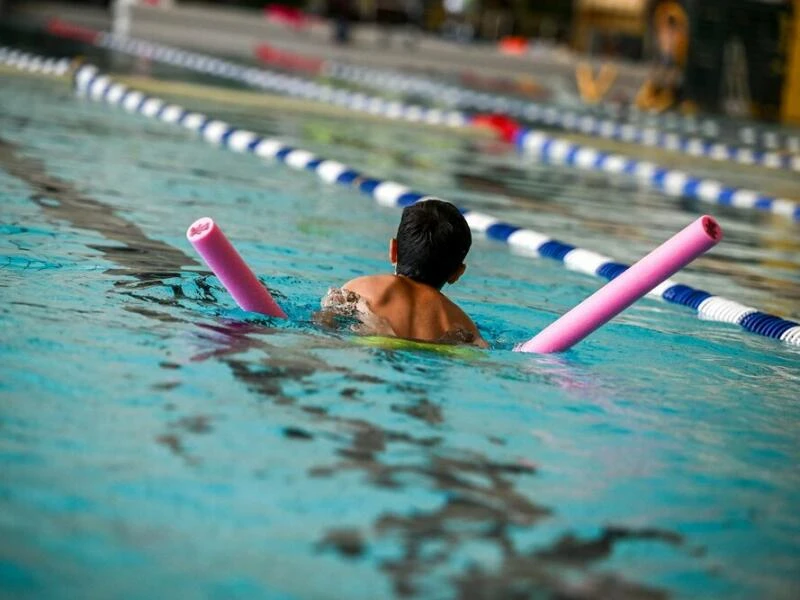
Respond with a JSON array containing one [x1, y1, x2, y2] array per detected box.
[[74, 65, 800, 346]]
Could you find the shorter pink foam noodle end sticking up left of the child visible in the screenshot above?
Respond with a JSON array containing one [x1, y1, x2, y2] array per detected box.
[[186, 217, 286, 319]]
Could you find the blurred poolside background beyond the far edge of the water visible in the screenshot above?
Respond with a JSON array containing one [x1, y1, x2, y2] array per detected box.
[[0, 0, 800, 123]]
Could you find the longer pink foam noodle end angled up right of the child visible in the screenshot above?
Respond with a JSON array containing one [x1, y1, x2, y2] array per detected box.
[[515, 215, 722, 353]]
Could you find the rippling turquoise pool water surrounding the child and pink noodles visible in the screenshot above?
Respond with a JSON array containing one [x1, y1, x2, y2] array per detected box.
[[0, 37, 800, 598]]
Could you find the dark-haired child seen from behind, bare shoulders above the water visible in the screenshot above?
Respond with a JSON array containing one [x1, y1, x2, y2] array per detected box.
[[322, 198, 488, 348]]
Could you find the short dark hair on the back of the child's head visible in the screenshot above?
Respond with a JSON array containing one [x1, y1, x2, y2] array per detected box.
[[397, 199, 472, 289]]
